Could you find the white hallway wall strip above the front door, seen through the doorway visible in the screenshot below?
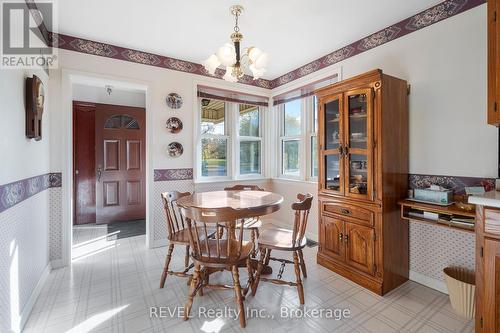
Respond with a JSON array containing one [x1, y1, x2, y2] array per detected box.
[[73, 84, 146, 108]]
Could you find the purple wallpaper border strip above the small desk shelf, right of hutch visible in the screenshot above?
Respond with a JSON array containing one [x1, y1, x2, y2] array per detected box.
[[408, 174, 495, 194]]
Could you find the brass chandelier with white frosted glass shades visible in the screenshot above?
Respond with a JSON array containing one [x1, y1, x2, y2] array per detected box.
[[202, 5, 269, 82]]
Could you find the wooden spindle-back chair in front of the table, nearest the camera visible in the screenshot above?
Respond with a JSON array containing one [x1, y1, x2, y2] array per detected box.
[[181, 207, 254, 327]]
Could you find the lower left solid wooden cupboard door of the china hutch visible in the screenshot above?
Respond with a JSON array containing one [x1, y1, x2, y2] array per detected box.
[[320, 215, 345, 261]]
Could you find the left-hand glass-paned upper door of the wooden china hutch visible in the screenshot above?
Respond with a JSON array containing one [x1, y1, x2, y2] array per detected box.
[[319, 95, 344, 194]]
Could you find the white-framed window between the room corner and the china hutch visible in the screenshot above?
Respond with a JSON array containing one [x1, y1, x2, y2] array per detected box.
[[277, 97, 318, 180]]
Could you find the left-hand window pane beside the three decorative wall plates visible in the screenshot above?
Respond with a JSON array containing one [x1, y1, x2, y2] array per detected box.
[[201, 100, 229, 177]]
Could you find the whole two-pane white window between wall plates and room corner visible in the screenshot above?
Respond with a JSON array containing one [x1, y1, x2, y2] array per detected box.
[[197, 98, 263, 181]]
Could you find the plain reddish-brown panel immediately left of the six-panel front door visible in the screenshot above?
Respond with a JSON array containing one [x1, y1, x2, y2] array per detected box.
[[73, 102, 95, 224]]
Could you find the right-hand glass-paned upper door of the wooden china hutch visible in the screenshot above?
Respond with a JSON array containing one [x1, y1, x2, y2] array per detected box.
[[343, 89, 373, 200]]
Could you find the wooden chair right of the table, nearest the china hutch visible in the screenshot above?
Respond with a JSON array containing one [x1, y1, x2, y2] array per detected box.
[[252, 194, 313, 304]]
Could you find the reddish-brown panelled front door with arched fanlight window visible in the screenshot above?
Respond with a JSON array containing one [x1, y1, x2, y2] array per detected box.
[[95, 104, 146, 223]]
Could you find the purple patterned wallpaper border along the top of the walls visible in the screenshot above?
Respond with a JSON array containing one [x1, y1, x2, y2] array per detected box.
[[26, 0, 486, 89]]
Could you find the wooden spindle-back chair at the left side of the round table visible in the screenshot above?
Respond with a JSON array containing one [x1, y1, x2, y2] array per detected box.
[[160, 191, 194, 288]]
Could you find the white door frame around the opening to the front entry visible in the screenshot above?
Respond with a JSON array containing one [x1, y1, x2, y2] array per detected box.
[[59, 69, 153, 268]]
